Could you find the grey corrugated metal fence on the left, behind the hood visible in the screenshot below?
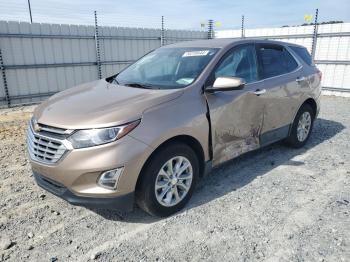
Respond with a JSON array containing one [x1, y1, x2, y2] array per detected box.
[[0, 21, 207, 106]]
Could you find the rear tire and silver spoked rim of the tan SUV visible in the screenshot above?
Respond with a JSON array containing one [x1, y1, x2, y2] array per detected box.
[[286, 104, 315, 148]]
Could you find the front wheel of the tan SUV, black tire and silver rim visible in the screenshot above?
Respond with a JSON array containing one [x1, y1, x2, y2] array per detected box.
[[136, 143, 199, 217]]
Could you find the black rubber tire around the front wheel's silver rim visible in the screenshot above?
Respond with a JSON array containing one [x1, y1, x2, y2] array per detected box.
[[136, 143, 199, 217]]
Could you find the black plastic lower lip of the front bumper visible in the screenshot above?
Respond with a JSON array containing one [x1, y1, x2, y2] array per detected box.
[[33, 172, 134, 211]]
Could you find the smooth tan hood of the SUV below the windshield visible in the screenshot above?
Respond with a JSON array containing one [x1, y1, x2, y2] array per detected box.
[[34, 79, 183, 129]]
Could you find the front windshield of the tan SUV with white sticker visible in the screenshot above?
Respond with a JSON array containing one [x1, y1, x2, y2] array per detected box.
[[114, 48, 218, 89]]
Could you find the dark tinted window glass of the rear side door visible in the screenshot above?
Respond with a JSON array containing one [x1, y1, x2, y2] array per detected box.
[[258, 45, 298, 78]]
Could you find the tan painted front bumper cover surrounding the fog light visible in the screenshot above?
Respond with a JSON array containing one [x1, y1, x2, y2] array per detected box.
[[29, 132, 152, 200]]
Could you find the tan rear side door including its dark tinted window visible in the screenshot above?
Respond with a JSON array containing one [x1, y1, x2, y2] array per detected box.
[[256, 43, 305, 145]]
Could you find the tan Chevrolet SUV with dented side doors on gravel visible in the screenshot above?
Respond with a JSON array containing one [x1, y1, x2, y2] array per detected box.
[[27, 39, 321, 216]]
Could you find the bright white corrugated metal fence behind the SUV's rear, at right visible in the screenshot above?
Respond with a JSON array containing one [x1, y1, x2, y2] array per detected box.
[[215, 23, 350, 91]]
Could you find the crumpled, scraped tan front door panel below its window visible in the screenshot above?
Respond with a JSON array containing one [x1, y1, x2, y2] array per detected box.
[[206, 83, 264, 165]]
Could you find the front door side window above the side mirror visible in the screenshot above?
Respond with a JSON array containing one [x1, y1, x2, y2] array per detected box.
[[214, 45, 258, 83]]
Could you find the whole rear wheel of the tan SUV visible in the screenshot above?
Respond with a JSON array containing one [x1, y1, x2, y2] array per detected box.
[[286, 104, 315, 148]]
